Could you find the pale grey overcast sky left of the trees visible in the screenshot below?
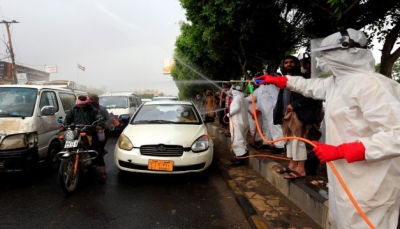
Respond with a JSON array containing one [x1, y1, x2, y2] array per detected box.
[[0, 0, 185, 95]]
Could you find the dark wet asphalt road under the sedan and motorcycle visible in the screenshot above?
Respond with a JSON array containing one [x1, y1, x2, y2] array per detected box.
[[0, 136, 251, 229]]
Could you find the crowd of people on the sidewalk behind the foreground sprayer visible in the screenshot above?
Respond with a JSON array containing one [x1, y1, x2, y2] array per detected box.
[[193, 55, 323, 175]]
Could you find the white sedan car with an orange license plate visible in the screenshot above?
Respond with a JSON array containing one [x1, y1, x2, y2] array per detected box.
[[114, 100, 214, 174]]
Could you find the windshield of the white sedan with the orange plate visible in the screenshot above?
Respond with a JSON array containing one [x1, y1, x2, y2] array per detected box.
[[131, 104, 201, 124]]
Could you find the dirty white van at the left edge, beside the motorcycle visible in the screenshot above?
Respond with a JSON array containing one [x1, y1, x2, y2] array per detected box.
[[0, 85, 82, 172]]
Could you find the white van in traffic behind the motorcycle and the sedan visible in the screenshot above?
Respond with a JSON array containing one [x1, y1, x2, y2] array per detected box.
[[99, 92, 142, 130]]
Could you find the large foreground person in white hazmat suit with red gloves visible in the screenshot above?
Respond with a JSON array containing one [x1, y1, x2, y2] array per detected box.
[[256, 29, 400, 229]]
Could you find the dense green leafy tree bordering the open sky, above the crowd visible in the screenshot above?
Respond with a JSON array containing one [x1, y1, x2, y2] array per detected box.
[[176, 0, 304, 79]]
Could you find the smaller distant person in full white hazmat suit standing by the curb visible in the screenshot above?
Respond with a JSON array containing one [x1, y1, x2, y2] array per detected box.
[[227, 85, 250, 166]]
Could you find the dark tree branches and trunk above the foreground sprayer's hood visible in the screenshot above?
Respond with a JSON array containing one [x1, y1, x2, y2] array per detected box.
[[265, 0, 400, 77]]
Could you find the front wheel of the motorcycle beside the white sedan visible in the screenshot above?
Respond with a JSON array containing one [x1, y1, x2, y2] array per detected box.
[[58, 156, 79, 193]]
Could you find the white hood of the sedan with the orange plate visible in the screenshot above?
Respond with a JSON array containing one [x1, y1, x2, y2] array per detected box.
[[123, 124, 207, 147]]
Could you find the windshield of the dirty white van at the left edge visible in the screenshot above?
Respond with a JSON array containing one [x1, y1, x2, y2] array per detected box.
[[0, 87, 38, 117]]
